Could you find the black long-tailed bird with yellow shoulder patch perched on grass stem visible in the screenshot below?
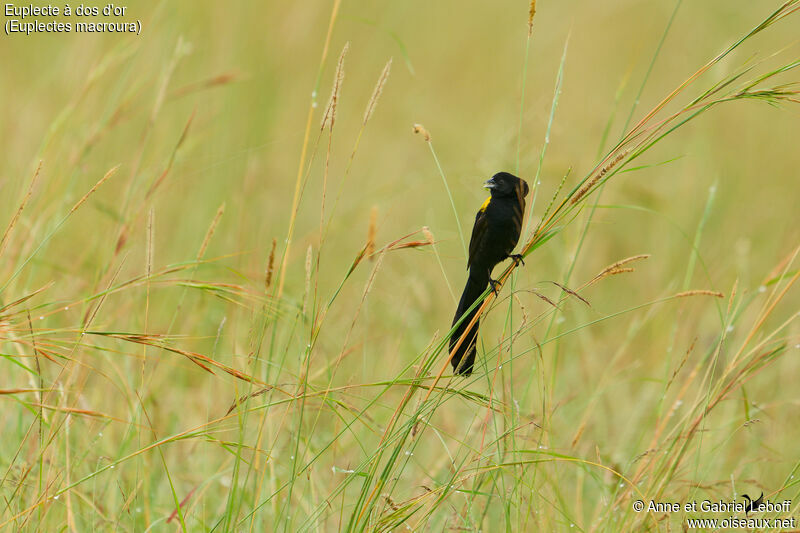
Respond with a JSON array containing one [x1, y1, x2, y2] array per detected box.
[[450, 172, 528, 375]]
